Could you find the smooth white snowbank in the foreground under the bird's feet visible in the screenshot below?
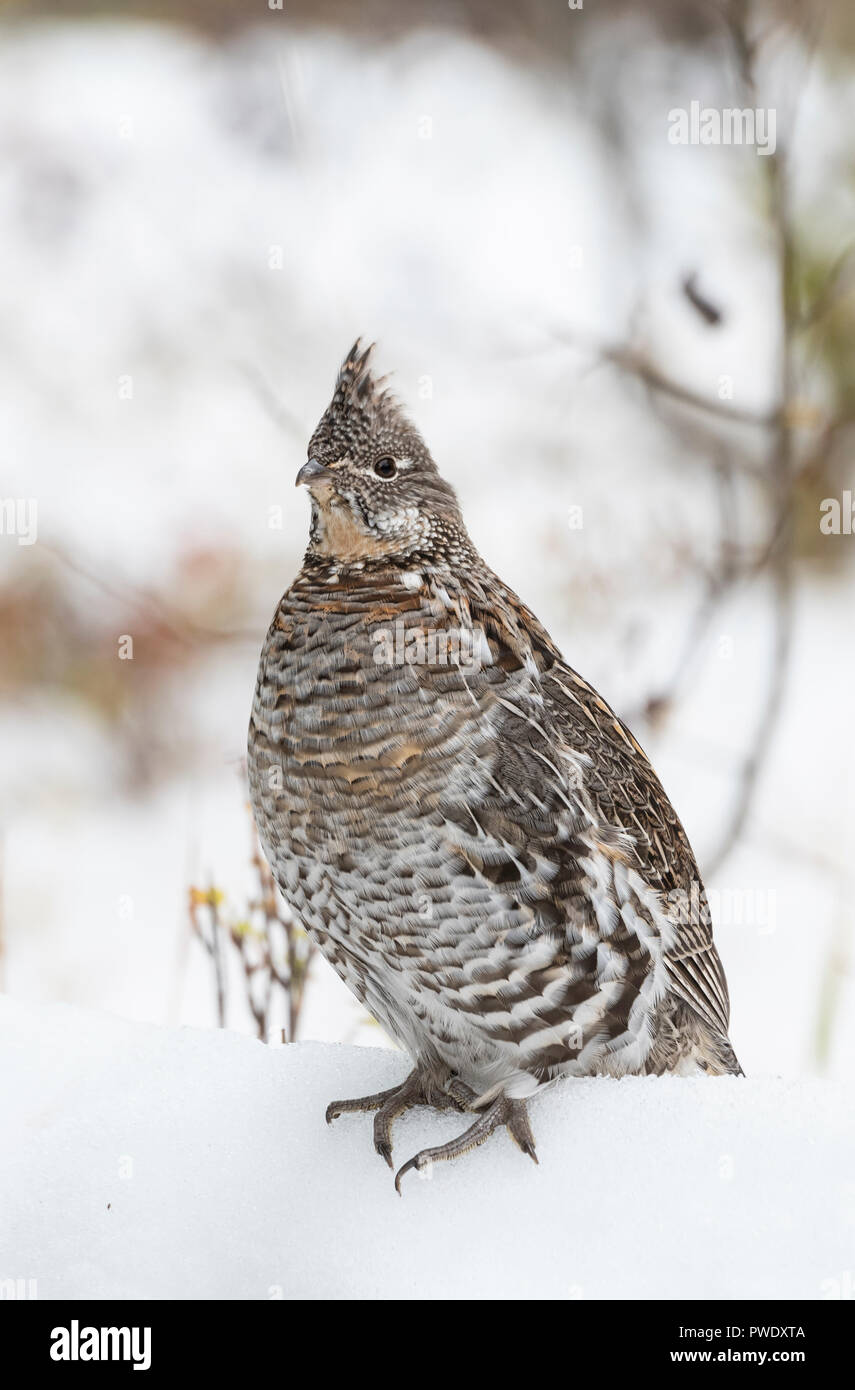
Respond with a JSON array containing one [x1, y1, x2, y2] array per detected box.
[[0, 998, 855, 1300]]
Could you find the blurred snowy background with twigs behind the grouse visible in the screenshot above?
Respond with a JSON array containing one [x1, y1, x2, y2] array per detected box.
[[0, 0, 855, 1076]]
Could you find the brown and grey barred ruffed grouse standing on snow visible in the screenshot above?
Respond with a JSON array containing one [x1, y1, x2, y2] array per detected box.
[[249, 342, 740, 1186]]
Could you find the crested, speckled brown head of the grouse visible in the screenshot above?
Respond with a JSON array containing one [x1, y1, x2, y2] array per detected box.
[[296, 339, 466, 564]]
